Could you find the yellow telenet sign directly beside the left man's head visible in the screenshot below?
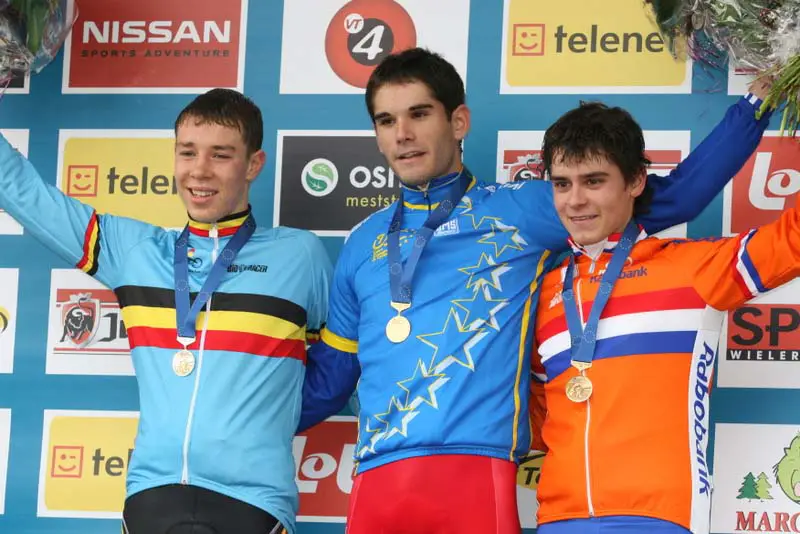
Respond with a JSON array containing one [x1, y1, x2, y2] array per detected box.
[[57, 130, 186, 228]]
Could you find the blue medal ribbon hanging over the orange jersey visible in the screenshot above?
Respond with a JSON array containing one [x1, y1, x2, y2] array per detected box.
[[562, 220, 639, 371]]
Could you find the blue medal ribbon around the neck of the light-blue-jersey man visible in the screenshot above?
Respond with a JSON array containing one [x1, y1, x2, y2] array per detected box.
[[174, 214, 256, 349]]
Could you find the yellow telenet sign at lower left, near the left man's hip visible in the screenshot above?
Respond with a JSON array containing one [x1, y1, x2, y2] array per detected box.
[[38, 410, 139, 518]]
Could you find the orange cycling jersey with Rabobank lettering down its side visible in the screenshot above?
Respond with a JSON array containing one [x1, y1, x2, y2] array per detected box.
[[531, 209, 800, 533]]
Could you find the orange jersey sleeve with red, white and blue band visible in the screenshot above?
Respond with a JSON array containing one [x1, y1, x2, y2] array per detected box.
[[694, 201, 800, 310]]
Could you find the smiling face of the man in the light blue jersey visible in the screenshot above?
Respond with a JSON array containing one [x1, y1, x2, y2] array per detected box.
[[175, 116, 266, 223]]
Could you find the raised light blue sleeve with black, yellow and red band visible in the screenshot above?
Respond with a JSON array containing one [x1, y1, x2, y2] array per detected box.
[[0, 131, 160, 288]]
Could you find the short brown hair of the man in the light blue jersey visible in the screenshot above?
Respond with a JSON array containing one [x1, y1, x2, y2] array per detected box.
[[175, 89, 264, 154]]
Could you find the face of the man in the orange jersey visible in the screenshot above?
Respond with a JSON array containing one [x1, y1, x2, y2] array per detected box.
[[550, 153, 645, 245]]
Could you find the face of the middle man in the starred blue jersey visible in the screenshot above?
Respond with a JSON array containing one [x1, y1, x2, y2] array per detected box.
[[373, 81, 470, 186]]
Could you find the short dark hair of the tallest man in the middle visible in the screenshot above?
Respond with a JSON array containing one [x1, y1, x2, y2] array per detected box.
[[364, 48, 466, 121]]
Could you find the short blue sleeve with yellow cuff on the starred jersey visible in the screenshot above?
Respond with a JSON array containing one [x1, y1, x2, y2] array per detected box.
[[321, 234, 361, 354]]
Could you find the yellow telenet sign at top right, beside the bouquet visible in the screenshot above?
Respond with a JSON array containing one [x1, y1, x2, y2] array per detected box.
[[501, 0, 691, 93]]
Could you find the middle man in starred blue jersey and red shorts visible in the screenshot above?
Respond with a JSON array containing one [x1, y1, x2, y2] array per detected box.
[[300, 49, 767, 534]]
